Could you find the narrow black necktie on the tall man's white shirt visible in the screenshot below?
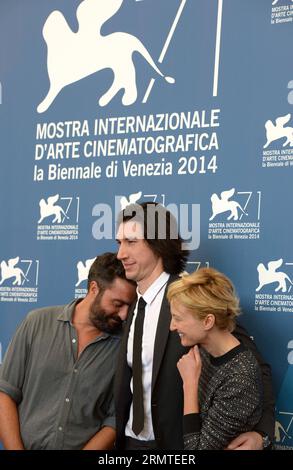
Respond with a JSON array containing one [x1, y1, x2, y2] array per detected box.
[[132, 297, 146, 435]]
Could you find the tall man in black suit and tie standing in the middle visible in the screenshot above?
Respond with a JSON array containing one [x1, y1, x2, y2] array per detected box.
[[115, 202, 274, 450]]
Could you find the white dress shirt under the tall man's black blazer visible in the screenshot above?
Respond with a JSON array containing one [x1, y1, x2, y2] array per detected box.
[[125, 272, 170, 441]]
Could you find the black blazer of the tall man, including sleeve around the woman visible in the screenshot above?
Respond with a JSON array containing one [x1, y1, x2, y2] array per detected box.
[[115, 276, 274, 450]]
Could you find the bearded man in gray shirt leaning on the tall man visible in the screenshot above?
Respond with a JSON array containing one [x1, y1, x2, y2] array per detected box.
[[0, 253, 136, 450]]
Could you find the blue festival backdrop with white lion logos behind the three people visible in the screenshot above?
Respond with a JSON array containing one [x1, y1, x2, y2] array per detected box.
[[0, 0, 293, 449]]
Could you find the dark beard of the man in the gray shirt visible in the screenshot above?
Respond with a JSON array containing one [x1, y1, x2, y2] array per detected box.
[[90, 292, 123, 334]]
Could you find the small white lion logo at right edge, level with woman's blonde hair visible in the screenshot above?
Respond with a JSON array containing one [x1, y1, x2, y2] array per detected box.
[[255, 258, 293, 312]]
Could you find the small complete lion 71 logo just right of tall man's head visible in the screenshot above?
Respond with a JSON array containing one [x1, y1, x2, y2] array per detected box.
[[208, 188, 262, 240]]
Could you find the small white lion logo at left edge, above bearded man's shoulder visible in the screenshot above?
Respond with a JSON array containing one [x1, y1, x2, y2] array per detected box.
[[0, 256, 40, 302]]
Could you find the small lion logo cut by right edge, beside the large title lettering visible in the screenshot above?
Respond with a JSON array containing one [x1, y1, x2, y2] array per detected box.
[[262, 113, 293, 168]]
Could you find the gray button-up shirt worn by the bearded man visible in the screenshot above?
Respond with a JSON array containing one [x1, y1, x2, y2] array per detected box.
[[0, 301, 119, 449]]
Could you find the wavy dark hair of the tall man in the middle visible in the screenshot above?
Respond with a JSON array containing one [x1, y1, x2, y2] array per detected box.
[[117, 202, 189, 274]]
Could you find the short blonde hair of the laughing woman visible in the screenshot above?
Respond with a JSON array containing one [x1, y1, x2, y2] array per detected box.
[[167, 268, 240, 331]]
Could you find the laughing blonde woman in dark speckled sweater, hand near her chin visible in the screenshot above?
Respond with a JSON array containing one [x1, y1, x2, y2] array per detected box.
[[167, 268, 262, 450]]
